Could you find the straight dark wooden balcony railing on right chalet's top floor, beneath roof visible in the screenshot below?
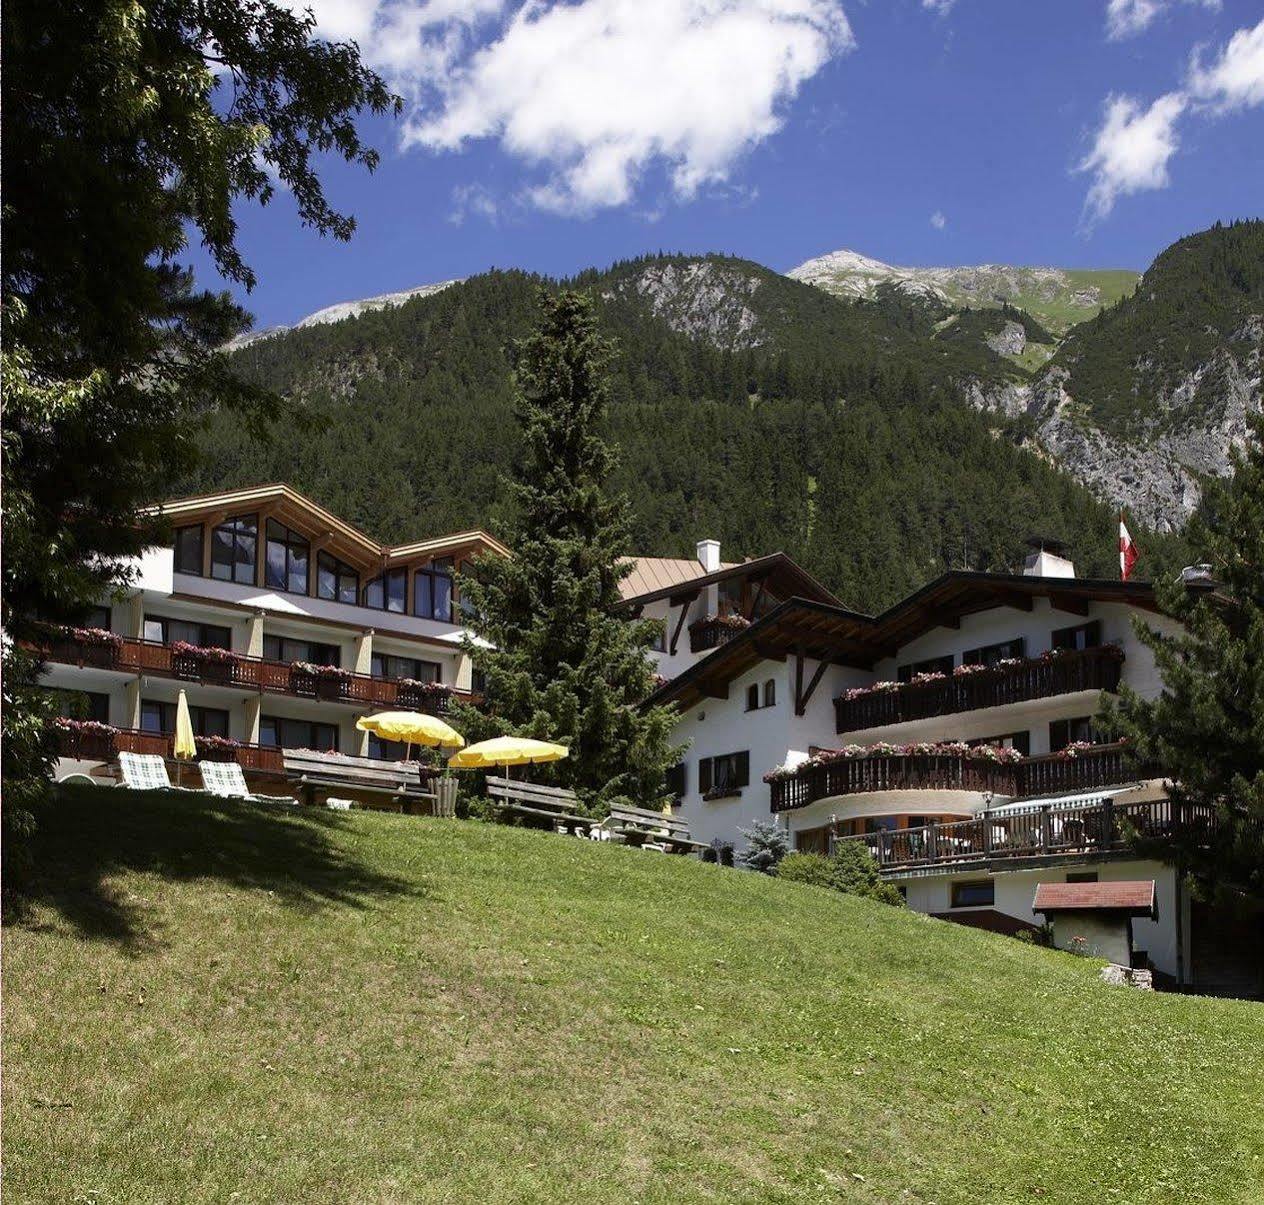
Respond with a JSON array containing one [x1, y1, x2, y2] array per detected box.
[[834, 645, 1124, 732]]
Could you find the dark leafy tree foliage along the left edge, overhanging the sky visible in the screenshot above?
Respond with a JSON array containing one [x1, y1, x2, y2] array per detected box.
[[3, 0, 396, 864]]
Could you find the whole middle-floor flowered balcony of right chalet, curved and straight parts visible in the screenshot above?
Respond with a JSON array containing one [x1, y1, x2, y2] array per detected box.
[[769, 743, 1153, 813]]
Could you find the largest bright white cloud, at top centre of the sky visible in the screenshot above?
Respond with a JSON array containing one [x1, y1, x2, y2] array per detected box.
[[404, 0, 853, 212]]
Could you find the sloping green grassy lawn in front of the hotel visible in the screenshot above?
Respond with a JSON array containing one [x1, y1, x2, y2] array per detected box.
[[4, 789, 1264, 1205]]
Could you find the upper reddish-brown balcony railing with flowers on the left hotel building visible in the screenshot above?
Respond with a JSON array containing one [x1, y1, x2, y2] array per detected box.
[[39, 637, 479, 714]]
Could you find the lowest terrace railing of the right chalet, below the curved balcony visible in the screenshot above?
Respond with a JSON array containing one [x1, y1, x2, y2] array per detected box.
[[834, 798, 1216, 871]]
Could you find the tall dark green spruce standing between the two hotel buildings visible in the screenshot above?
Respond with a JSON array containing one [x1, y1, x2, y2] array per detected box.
[[456, 291, 674, 808]]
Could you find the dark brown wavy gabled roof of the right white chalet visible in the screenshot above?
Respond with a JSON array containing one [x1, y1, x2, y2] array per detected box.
[[646, 569, 1158, 707]]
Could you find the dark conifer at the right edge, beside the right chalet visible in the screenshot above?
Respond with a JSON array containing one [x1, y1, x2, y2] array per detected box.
[[1105, 417, 1264, 896]]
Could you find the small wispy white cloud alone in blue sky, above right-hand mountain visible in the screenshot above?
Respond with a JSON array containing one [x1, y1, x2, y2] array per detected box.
[[1077, 92, 1187, 221]]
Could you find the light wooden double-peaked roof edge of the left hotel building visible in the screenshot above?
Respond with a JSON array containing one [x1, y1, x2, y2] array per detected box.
[[150, 483, 509, 568]]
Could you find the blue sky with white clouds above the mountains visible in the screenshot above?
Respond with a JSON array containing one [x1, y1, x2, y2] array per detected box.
[[192, 0, 1264, 326]]
